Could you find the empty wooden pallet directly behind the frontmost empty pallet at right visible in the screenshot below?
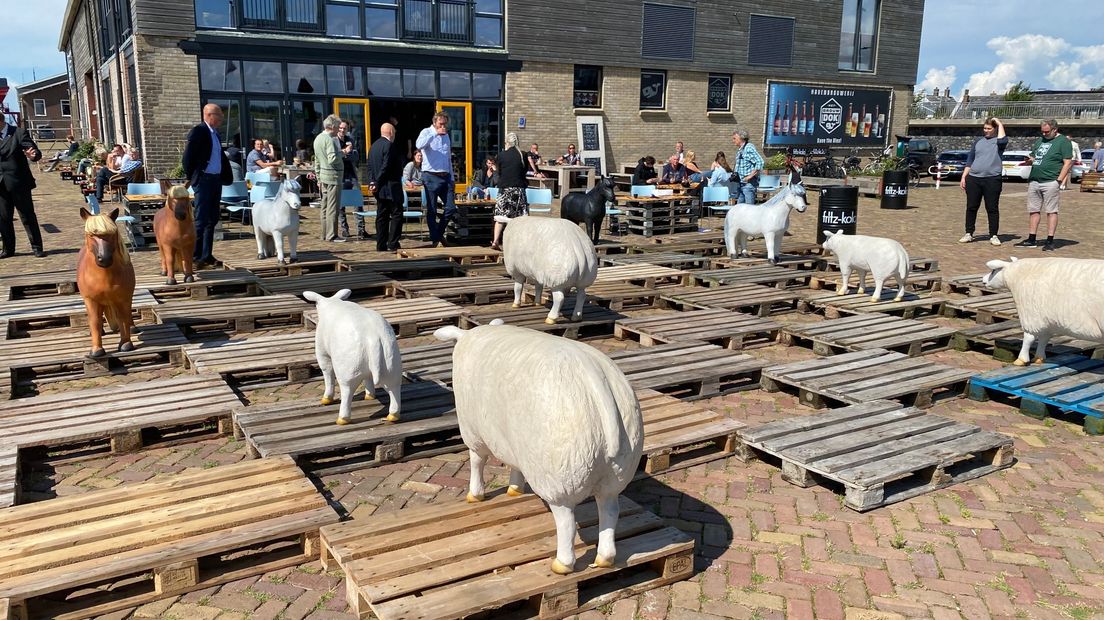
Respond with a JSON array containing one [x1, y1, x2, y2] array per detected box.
[[762, 349, 973, 409]]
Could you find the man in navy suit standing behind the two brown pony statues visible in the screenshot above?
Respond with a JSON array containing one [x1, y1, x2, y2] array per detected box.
[[181, 104, 234, 268]]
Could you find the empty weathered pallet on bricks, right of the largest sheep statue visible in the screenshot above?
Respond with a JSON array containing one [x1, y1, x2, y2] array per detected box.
[[739, 400, 1013, 512]]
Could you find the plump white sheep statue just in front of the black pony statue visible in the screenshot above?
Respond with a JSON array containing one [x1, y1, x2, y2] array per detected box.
[[502, 215, 598, 324]]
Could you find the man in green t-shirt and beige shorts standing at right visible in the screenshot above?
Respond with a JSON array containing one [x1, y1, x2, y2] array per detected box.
[[1016, 119, 1073, 252]]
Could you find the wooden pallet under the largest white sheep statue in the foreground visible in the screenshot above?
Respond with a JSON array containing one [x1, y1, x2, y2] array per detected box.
[[321, 494, 694, 620]]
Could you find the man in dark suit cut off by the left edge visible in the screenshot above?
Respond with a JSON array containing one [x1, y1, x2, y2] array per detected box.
[[0, 124, 45, 258]]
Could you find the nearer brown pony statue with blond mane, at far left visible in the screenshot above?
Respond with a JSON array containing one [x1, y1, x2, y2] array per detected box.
[[76, 209, 135, 357]]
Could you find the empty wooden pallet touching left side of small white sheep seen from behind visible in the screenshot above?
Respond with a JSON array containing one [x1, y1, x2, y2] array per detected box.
[[184, 332, 321, 385]]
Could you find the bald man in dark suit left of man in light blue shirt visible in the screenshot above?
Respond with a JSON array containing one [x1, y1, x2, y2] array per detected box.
[[368, 122, 404, 252]]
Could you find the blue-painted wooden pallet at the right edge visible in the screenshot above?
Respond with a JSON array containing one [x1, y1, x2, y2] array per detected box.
[[967, 354, 1104, 435]]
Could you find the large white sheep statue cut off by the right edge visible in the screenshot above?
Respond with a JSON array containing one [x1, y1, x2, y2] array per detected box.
[[981, 257, 1104, 366]]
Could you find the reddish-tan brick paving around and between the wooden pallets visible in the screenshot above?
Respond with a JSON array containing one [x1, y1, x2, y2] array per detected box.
[[0, 170, 1104, 620]]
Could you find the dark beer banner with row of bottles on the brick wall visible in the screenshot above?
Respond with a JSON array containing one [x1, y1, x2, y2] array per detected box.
[[764, 82, 892, 148]]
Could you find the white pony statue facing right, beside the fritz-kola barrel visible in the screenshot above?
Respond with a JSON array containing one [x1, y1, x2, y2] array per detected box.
[[724, 170, 808, 264]]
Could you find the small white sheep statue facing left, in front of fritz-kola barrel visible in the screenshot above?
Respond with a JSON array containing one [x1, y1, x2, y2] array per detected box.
[[821, 231, 909, 301]]
